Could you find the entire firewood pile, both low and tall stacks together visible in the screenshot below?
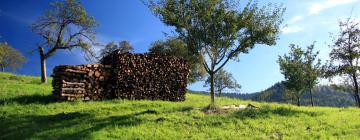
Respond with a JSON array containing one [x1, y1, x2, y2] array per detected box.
[[52, 51, 189, 101]]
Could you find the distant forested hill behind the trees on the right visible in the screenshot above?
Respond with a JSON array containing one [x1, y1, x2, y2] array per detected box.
[[193, 82, 355, 107]]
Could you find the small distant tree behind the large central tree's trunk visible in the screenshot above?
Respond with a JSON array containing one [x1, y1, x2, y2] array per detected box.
[[204, 69, 241, 96]]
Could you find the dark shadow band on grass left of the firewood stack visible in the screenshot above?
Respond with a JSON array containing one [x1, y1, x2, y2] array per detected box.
[[0, 94, 57, 106]]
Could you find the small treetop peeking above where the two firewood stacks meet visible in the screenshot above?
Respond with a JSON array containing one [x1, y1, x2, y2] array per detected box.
[[98, 41, 134, 59]]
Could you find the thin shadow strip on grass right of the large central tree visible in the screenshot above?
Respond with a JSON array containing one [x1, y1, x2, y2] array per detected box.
[[233, 107, 321, 119]]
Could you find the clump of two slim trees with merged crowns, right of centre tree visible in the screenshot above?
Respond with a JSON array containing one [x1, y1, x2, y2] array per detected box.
[[278, 44, 321, 106]]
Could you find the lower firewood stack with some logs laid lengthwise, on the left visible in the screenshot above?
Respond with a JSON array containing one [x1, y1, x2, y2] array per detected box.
[[52, 64, 111, 100]]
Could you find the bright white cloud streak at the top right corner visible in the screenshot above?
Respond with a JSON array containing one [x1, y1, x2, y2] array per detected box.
[[309, 0, 359, 15]]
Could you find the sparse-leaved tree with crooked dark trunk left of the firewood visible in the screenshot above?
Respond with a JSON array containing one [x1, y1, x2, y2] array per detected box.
[[32, 0, 97, 83]]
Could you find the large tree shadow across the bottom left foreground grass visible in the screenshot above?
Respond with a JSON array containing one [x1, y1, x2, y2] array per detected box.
[[0, 110, 155, 139]]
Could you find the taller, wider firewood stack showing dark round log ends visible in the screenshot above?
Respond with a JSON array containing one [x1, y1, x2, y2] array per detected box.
[[101, 51, 189, 101]]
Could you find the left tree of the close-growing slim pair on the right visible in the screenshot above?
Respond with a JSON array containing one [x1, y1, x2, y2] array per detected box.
[[278, 44, 307, 106]]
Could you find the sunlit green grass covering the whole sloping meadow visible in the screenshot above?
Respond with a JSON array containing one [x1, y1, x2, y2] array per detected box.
[[0, 73, 360, 139]]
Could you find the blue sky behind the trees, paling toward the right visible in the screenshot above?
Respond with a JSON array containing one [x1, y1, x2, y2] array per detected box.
[[0, 0, 360, 93]]
